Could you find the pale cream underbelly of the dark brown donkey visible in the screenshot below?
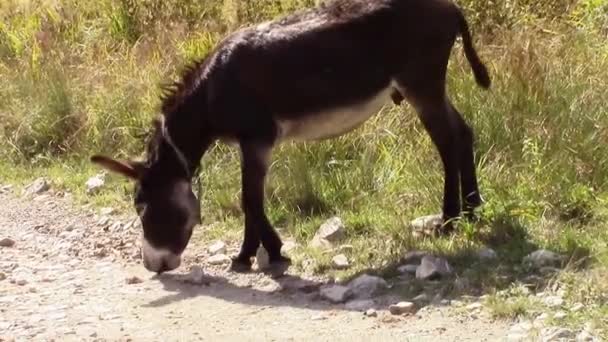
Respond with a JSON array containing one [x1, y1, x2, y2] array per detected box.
[[278, 82, 396, 141]]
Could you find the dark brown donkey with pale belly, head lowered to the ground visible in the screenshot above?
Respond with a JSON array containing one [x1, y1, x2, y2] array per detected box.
[[92, 0, 490, 272]]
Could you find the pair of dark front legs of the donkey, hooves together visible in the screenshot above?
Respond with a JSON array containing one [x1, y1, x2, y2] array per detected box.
[[233, 141, 291, 274]]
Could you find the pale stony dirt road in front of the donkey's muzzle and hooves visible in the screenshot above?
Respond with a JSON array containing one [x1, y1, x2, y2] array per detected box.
[[0, 188, 509, 341]]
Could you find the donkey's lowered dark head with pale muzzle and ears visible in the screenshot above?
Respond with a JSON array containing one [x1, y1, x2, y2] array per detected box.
[[91, 120, 200, 273]]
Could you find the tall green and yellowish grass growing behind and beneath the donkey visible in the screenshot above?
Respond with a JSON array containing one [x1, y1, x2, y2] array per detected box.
[[0, 0, 608, 336]]
